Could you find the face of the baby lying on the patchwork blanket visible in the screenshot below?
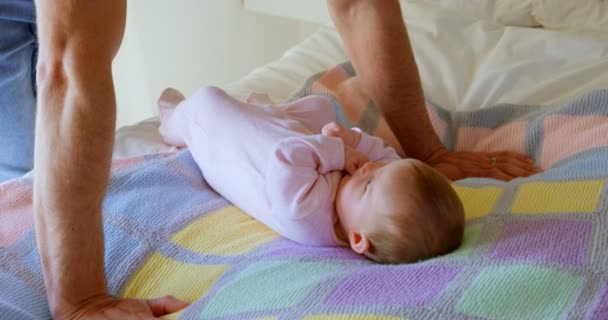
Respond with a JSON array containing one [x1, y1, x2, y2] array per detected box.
[[336, 159, 415, 234]]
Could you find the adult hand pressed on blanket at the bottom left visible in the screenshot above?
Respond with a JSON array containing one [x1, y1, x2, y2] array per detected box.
[[55, 296, 188, 320]]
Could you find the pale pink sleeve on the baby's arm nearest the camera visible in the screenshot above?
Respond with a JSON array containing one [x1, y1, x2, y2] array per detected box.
[[265, 134, 344, 246]]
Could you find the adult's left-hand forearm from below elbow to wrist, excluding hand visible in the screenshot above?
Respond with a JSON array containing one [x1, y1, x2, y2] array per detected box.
[[34, 62, 115, 316]]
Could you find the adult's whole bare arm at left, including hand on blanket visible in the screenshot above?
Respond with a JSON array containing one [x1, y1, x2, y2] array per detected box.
[[34, 0, 183, 319]]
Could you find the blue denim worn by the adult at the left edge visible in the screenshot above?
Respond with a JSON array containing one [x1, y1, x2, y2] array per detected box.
[[0, 0, 38, 183]]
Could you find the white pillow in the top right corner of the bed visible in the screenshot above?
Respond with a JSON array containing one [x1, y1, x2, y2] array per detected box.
[[534, 0, 608, 32]]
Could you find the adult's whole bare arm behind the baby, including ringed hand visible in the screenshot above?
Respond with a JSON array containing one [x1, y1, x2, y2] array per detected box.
[[328, 0, 534, 180]]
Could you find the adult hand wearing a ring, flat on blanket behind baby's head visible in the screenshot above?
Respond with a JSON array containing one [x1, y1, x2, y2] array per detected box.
[[426, 150, 542, 181]]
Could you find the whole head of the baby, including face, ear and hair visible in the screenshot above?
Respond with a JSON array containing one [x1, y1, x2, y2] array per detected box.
[[336, 159, 464, 263]]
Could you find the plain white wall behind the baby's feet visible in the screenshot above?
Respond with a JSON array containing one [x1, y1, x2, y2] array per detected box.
[[114, 0, 314, 126]]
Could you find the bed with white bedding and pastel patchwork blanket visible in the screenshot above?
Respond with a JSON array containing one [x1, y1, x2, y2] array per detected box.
[[0, 0, 608, 320]]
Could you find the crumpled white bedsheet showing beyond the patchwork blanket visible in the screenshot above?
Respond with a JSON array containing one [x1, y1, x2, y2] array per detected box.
[[114, 8, 608, 157]]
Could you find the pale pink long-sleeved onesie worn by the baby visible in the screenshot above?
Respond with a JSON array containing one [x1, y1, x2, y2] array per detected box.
[[168, 87, 399, 246]]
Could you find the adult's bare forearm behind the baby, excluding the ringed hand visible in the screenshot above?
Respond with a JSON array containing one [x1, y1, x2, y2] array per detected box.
[[328, 0, 443, 160]]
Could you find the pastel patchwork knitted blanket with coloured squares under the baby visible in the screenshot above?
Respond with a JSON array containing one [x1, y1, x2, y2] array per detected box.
[[0, 60, 608, 320]]
